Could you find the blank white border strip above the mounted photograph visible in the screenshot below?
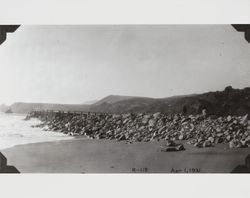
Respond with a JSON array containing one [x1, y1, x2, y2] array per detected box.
[[0, 0, 250, 24]]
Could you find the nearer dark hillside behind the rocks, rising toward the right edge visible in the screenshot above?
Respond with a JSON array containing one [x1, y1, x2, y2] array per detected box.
[[90, 86, 250, 115]]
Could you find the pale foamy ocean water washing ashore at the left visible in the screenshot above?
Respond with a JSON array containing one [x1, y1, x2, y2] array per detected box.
[[0, 113, 72, 149]]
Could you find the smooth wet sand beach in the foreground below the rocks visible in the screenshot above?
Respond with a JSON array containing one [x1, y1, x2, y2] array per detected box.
[[1, 138, 250, 173]]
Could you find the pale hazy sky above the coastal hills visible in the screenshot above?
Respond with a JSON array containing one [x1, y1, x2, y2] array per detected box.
[[0, 25, 250, 104]]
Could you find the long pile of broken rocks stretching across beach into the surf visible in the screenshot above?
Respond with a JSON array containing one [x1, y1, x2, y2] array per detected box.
[[26, 111, 250, 148]]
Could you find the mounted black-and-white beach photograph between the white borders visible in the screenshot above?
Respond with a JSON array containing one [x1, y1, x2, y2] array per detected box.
[[0, 24, 250, 174]]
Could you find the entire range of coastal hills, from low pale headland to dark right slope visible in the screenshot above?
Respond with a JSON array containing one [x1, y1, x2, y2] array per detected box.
[[1, 86, 250, 115]]
